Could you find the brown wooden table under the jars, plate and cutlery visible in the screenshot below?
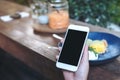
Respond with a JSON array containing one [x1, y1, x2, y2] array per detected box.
[[0, 0, 120, 80]]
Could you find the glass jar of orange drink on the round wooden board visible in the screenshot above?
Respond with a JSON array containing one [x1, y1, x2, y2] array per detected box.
[[48, 0, 69, 29]]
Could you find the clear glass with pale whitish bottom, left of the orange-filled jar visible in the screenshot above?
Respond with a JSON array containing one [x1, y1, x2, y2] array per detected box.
[[29, 0, 48, 24]]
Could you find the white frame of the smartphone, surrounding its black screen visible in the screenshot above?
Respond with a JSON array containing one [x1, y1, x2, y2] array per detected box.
[[56, 24, 89, 72]]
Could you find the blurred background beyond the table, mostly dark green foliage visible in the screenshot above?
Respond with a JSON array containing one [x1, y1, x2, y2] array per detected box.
[[5, 0, 120, 31]]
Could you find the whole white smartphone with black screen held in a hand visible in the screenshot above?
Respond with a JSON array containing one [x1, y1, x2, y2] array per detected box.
[[56, 24, 89, 72]]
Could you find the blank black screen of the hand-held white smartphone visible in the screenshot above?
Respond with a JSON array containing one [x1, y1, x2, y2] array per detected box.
[[58, 29, 87, 66]]
